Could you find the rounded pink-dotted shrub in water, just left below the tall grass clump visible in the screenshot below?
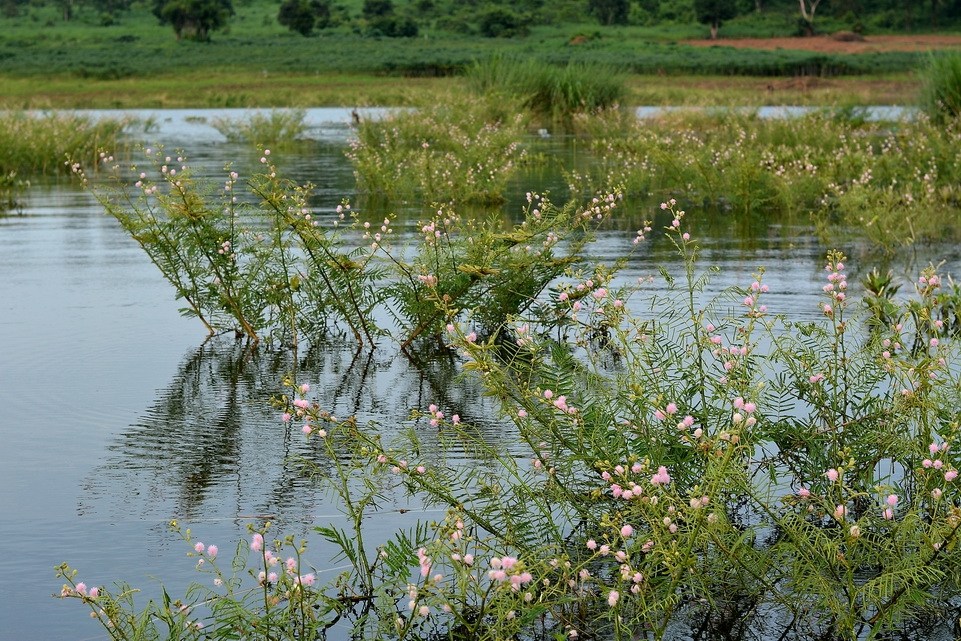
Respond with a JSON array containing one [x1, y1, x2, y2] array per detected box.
[[347, 92, 525, 203]]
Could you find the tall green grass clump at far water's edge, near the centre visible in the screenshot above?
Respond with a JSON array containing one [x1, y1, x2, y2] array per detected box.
[[466, 56, 626, 122]]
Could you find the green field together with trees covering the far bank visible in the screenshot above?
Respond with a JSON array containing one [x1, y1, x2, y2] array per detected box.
[[0, 0, 961, 104]]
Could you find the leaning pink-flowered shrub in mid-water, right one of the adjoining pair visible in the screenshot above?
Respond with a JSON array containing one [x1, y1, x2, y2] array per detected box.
[[387, 192, 619, 348]]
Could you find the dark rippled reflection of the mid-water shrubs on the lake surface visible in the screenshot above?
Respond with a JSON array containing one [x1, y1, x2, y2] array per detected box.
[[78, 338, 509, 527]]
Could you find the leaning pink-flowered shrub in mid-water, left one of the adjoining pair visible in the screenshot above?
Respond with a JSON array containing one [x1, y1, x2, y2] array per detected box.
[[73, 149, 386, 345]]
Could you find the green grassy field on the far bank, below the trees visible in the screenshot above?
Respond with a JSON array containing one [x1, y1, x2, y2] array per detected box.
[[0, 0, 956, 108]]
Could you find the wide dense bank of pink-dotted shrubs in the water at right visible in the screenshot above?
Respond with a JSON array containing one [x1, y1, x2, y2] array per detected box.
[[569, 110, 961, 251]]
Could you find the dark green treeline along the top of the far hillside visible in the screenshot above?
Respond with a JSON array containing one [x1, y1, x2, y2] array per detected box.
[[0, 0, 961, 40]]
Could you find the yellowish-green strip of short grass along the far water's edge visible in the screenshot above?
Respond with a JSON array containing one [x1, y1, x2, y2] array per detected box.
[[0, 69, 920, 109]]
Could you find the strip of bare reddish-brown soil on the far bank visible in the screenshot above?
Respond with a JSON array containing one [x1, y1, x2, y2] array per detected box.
[[683, 34, 961, 54]]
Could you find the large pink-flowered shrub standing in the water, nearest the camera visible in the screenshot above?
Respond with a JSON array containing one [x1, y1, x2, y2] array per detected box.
[[62, 203, 961, 641]]
